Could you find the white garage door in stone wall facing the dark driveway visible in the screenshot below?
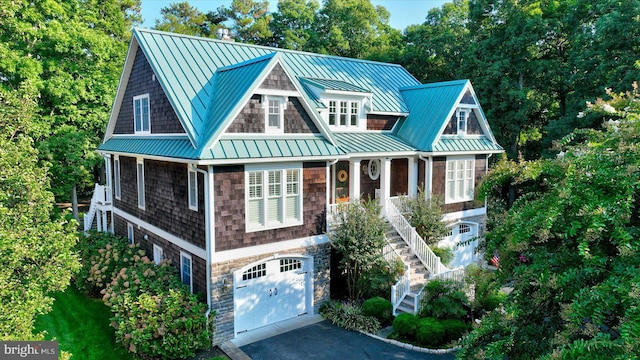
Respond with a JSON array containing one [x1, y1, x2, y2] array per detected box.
[[234, 257, 311, 334]]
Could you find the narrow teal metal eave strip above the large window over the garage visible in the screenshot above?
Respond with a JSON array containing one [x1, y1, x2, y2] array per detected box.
[[206, 138, 344, 160]]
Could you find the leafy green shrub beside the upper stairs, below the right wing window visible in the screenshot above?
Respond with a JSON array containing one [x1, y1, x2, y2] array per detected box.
[[402, 191, 449, 244]]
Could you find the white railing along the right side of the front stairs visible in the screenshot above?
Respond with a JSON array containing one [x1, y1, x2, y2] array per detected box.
[[386, 198, 449, 274]]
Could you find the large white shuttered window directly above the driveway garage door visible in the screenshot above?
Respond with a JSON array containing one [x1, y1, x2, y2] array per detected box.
[[245, 165, 302, 231]]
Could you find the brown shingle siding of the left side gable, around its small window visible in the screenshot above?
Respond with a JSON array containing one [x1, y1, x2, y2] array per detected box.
[[114, 50, 185, 134]]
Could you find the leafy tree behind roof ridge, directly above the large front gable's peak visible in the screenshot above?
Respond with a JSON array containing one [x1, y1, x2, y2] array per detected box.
[[269, 0, 320, 51]]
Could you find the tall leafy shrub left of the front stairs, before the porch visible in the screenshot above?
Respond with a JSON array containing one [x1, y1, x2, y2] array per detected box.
[[329, 200, 385, 300]]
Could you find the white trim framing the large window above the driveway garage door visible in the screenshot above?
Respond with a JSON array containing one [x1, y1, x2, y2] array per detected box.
[[244, 163, 304, 233]]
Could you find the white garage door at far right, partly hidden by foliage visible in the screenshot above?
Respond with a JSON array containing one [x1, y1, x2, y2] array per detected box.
[[438, 223, 478, 268]]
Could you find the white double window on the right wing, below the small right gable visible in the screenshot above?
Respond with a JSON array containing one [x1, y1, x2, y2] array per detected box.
[[445, 157, 474, 203]]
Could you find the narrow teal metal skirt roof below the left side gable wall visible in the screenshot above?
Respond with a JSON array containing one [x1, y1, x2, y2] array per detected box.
[[98, 136, 198, 159]]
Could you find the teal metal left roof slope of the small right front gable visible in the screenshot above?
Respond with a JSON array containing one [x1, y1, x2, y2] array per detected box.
[[394, 80, 469, 151]]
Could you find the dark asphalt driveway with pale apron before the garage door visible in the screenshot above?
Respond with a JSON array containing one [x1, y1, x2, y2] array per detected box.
[[224, 315, 454, 360]]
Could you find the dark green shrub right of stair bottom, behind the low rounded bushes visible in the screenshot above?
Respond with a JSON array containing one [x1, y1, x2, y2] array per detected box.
[[420, 280, 469, 319]]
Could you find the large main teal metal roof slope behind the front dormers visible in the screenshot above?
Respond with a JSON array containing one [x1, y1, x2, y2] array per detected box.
[[133, 28, 419, 150]]
